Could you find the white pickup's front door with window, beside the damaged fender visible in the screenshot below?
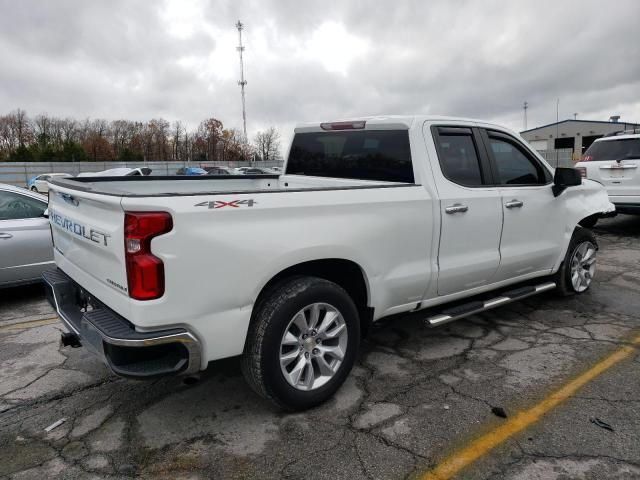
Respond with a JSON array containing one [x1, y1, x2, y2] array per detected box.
[[482, 130, 566, 281]]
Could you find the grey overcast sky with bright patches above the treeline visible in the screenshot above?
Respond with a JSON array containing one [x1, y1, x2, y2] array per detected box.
[[0, 0, 640, 146]]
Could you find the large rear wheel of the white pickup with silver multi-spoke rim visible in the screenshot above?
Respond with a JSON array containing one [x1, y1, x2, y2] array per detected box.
[[241, 276, 360, 411]]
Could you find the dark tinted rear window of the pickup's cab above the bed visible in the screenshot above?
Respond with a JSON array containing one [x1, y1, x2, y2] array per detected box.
[[287, 130, 414, 183]]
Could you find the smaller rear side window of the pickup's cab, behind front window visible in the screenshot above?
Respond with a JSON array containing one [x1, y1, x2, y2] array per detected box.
[[436, 128, 484, 187]]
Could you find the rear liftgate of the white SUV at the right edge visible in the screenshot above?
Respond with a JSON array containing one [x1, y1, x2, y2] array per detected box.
[[581, 137, 640, 196]]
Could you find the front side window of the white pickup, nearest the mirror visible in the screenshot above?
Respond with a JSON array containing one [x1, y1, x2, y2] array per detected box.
[[489, 134, 550, 185]]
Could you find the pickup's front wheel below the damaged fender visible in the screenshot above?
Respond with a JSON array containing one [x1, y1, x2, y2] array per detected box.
[[554, 227, 598, 296]]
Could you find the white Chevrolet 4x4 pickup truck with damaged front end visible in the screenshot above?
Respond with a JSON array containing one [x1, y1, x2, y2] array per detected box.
[[44, 116, 614, 410]]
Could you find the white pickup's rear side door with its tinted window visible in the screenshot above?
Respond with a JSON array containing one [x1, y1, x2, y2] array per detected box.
[[431, 126, 502, 295]]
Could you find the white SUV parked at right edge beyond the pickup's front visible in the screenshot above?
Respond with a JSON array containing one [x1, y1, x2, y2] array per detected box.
[[575, 129, 640, 227]]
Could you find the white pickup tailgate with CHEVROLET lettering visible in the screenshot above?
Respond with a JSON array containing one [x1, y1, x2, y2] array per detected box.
[[49, 185, 127, 296]]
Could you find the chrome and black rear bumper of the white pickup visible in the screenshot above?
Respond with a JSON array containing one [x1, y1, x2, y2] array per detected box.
[[42, 268, 202, 378]]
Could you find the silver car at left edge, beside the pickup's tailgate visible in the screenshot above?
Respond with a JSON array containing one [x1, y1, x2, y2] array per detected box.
[[0, 184, 52, 288]]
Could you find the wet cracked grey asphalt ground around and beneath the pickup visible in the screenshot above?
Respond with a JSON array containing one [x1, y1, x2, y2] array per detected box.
[[0, 216, 640, 480]]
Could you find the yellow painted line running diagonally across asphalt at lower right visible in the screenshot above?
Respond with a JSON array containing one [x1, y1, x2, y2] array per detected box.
[[419, 336, 640, 480]]
